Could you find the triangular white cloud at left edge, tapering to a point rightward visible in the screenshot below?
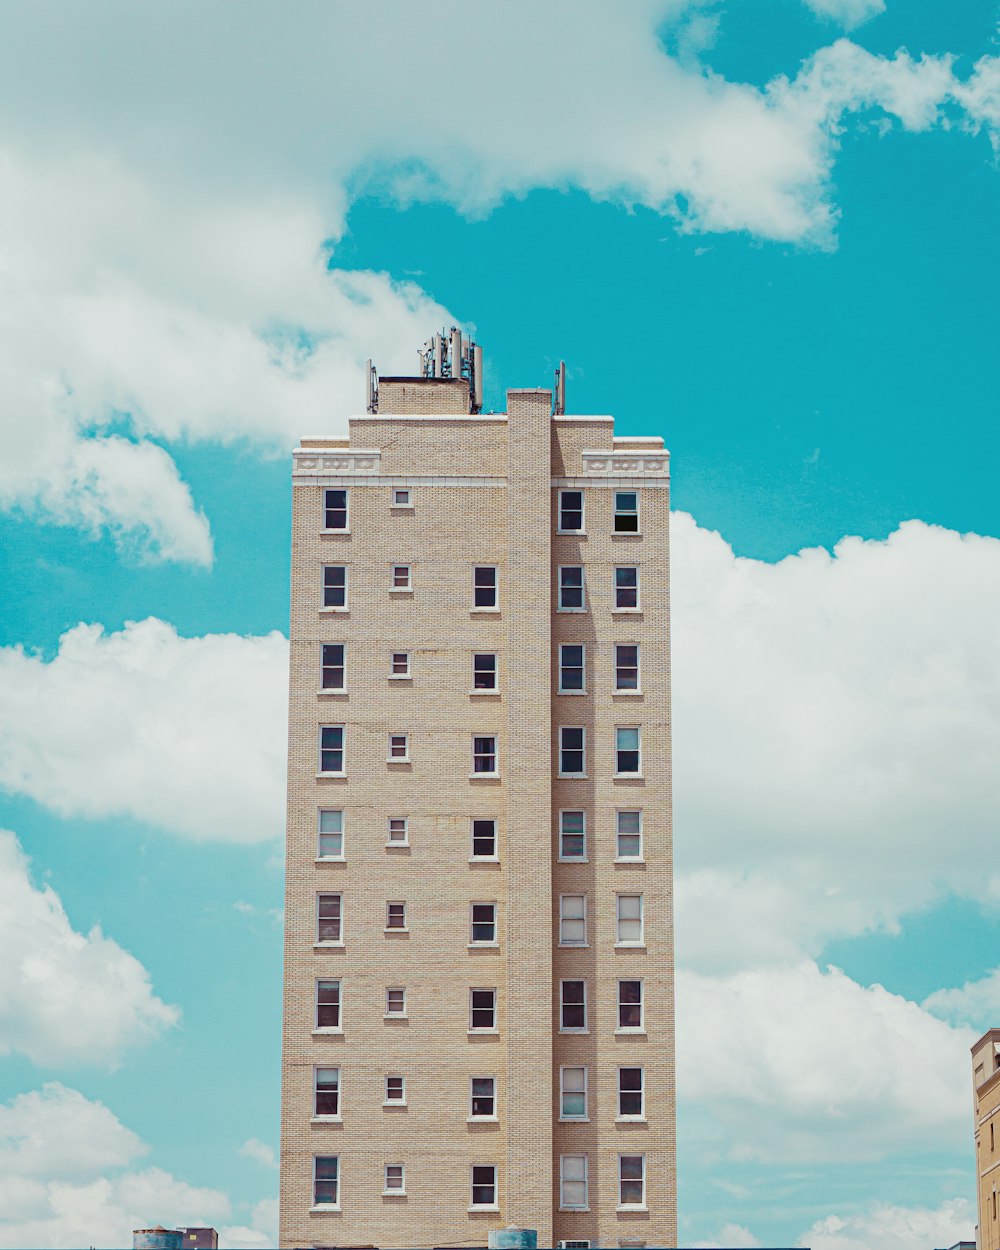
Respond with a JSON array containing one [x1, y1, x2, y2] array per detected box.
[[0, 831, 179, 1065]]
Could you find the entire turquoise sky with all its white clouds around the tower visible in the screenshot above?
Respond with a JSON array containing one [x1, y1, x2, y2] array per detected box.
[[0, 0, 1000, 1250]]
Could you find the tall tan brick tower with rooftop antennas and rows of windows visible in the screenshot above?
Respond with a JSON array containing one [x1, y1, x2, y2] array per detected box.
[[280, 333, 676, 1248]]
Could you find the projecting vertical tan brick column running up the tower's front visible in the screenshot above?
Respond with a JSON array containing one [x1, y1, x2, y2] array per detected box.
[[501, 390, 554, 1246]]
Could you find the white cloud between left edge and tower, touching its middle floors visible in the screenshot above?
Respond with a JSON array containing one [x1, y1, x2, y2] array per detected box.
[[0, 618, 288, 843]]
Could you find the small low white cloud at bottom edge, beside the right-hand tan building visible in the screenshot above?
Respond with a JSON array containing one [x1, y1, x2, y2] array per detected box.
[[799, 1198, 976, 1250]]
